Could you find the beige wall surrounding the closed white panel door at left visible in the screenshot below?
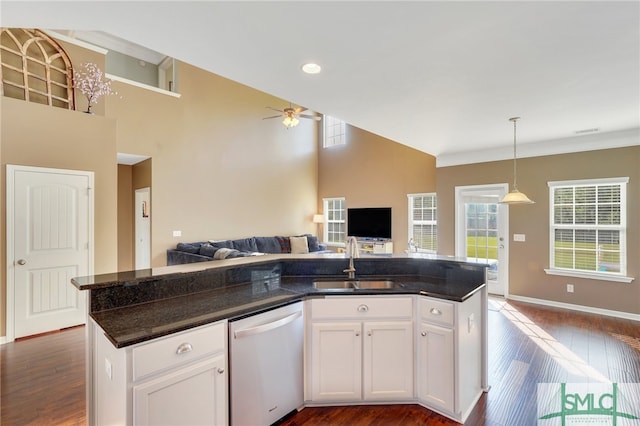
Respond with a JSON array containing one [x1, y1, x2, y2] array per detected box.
[[0, 97, 117, 335]]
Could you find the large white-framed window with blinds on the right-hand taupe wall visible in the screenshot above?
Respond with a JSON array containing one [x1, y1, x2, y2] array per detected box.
[[547, 178, 629, 281]]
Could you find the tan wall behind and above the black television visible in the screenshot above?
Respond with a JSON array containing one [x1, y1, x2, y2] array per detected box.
[[318, 126, 436, 253]]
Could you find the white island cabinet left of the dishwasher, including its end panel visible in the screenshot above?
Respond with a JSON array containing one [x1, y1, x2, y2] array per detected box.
[[88, 321, 229, 425]]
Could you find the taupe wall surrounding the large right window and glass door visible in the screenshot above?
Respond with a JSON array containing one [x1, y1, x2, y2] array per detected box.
[[437, 146, 640, 314]]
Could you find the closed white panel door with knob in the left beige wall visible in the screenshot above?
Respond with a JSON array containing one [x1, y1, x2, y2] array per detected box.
[[7, 165, 93, 340]]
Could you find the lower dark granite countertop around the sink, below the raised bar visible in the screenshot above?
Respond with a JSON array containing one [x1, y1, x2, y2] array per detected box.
[[90, 276, 485, 348]]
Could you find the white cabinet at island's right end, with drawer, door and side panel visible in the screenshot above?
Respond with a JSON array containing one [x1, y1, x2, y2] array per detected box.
[[417, 292, 482, 423]]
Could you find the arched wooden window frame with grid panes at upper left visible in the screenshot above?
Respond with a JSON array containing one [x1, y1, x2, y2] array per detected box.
[[0, 28, 75, 109]]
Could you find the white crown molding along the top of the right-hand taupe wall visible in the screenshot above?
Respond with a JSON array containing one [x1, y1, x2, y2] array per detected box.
[[436, 127, 640, 168]]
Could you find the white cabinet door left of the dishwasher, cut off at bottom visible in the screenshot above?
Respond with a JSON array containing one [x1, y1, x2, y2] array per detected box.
[[133, 355, 228, 426]]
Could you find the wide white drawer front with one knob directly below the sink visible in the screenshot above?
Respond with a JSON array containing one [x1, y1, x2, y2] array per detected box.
[[311, 296, 413, 320]]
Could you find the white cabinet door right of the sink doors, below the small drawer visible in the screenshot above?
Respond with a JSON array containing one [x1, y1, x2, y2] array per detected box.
[[418, 322, 454, 412]]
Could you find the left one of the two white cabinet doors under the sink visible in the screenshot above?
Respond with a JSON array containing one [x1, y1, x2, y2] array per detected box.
[[311, 322, 362, 401]]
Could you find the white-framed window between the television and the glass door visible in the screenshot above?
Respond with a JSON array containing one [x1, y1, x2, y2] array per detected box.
[[407, 194, 438, 253]]
